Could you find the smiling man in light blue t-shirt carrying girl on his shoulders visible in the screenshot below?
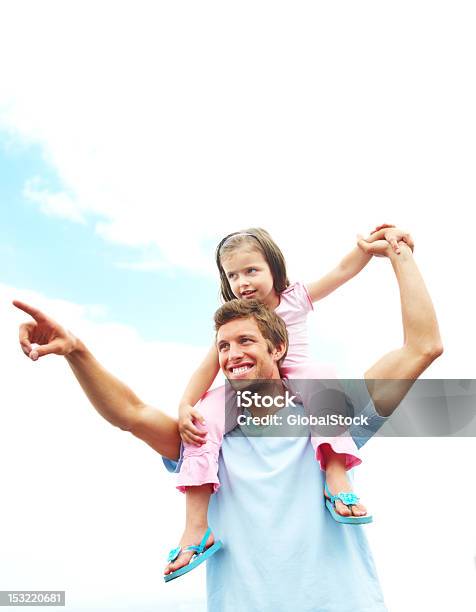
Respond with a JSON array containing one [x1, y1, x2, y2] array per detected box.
[[15, 241, 442, 612]]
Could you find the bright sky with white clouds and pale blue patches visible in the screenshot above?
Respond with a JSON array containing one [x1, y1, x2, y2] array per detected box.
[[0, 0, 476, 611]]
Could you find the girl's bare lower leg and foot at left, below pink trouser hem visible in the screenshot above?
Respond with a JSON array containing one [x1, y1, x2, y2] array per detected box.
[[164, 484, 215, 574]]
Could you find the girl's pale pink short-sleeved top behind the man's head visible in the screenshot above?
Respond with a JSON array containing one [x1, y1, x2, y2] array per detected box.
[[274, 283, 314, 367]]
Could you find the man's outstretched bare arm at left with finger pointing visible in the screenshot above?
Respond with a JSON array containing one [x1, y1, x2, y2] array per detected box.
[[13, 301, 180, 459]]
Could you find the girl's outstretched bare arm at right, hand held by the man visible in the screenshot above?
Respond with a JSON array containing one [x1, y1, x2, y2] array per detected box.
[[307, 225, 413, 302]]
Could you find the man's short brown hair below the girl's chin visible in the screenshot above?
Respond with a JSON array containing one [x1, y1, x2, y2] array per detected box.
[[213, 299, 289, 366]]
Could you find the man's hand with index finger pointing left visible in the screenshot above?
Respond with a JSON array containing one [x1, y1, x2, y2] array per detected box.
[[13, 300, 76, 361]]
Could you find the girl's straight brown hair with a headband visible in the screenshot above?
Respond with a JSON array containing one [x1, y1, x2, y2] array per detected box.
[[215, 227, 289, 302]]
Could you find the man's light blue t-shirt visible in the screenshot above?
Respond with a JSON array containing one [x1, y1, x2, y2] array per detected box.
[[164, 385, 386, 612]]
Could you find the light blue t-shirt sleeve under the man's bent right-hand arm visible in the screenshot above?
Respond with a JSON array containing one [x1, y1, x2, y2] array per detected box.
[[340, 378, 389, 448]]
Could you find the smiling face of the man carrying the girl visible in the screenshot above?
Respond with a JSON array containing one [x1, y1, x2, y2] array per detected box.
[[217, 318, 283, 381]]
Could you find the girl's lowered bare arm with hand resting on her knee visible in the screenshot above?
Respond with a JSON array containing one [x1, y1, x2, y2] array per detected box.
[[179, 345, 220, 445]]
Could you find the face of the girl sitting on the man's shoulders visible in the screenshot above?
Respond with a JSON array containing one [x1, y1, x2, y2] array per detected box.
[[221, 246, 279, 310]]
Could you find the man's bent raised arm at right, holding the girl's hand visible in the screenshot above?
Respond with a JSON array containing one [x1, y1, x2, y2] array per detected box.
[[359, 241, 443, 416]]
